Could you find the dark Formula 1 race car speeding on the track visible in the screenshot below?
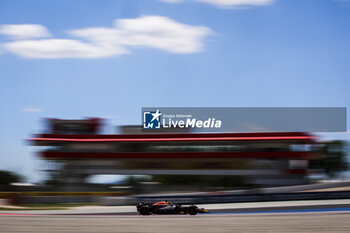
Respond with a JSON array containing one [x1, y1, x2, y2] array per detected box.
[[136, 201, 208, 215]]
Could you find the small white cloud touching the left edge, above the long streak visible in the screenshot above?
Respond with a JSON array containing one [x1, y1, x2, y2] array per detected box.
[[0, 24, 51, 39]]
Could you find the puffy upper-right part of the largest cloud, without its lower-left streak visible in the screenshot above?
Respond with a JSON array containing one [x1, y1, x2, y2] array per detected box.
[[69, 16, 211, 53]]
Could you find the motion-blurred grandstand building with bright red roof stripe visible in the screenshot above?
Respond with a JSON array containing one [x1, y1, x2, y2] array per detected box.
[[28, 118, 320, 187]]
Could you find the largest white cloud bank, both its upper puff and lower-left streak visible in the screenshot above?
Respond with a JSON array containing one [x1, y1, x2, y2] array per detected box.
[[3, 16, 211, 58]]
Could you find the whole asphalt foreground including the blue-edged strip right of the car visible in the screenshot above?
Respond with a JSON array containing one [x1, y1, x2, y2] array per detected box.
[[0, 202, 350, 233]]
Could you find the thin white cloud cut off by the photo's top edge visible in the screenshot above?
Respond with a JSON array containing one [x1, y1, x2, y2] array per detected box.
[[161, 0, 275, 8]]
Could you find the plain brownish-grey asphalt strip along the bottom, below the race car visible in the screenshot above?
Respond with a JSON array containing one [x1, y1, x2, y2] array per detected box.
[[0, 212, 350, 233]]
